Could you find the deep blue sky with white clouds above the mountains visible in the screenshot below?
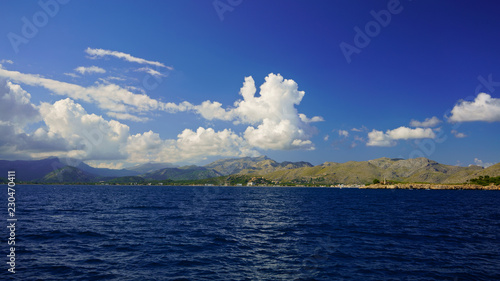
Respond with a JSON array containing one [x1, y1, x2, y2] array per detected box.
[[0, 0, 500, 168]]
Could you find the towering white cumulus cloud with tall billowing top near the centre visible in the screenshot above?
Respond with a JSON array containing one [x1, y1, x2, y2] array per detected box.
[[193, 73, 323, 150]]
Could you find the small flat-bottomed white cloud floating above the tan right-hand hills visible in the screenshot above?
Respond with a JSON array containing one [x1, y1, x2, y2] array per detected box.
[[366, 126, 436, 147]]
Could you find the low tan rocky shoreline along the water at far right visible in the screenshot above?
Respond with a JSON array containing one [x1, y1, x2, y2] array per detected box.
[[360, 183, 500, 190]]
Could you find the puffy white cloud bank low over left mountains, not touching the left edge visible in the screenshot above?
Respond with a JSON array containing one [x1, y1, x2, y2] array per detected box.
[[35, 99, 258, 161]]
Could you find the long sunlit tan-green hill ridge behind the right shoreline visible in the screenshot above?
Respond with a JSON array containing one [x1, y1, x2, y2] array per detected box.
[[262, 158, 484, 184]]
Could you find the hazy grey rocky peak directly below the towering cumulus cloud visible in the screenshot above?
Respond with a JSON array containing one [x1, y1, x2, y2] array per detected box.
[[204, 156, 313, 176]]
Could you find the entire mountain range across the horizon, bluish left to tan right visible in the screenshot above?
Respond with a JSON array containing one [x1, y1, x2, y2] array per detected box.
[[0, 156, 500, 184]]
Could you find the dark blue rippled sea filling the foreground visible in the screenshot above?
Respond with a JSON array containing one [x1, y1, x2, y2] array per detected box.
[[0, 186, 500, 280]]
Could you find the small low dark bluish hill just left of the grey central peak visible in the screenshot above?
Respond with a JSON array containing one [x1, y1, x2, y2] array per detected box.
[[143, 165, 221, 180]]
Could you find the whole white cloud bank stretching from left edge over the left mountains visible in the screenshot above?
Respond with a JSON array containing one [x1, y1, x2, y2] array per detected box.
[[0, 82, 259, 163]]
